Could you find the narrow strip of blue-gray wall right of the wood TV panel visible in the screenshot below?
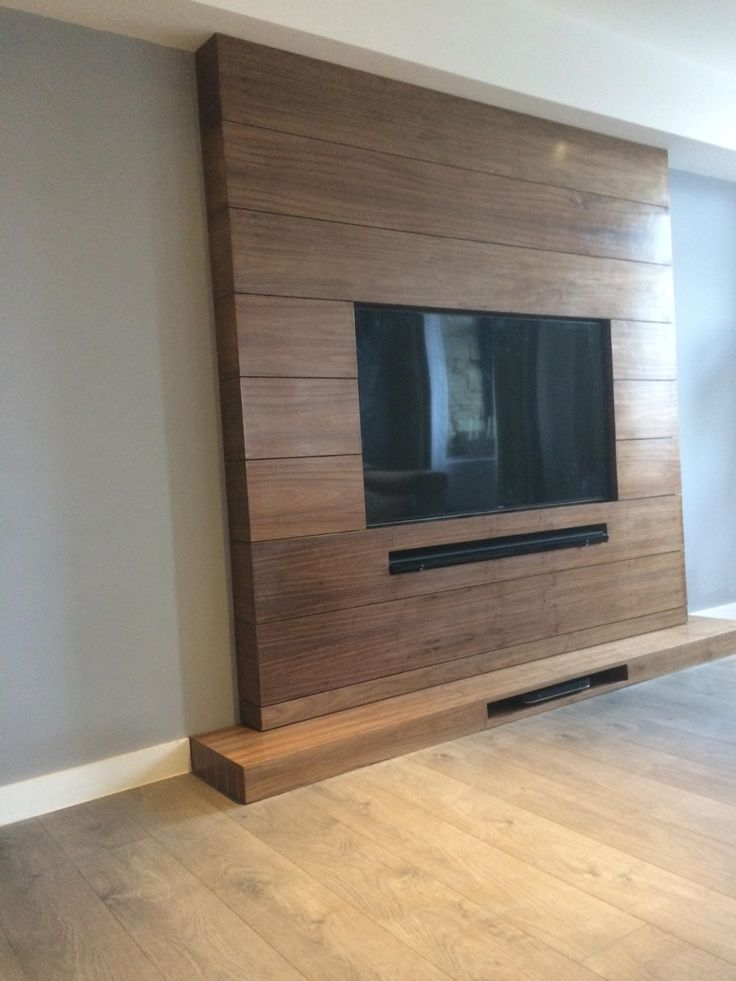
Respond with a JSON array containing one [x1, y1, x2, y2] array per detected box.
[[670, 171, 736, 610]]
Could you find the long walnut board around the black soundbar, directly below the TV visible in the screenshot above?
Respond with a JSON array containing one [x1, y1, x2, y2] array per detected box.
[[239, 498, 682, 622]]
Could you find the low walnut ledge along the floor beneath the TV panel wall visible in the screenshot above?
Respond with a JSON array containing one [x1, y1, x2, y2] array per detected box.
[[190, 617, 736, 804]]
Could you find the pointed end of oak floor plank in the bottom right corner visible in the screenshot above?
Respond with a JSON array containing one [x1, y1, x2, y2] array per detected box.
[[585, 926, 734, 981]]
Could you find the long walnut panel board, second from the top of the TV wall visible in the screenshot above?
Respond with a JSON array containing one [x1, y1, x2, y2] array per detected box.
[[220, 123, 671, 263]]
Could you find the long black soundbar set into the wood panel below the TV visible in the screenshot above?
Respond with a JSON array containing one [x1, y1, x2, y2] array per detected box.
[[388, 525, 608, 576]]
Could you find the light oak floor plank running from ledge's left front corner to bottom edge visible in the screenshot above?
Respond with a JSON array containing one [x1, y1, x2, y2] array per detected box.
[[122, 777, 446, 981]]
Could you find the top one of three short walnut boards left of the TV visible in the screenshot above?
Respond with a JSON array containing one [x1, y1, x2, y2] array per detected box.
[[217, 294, 357, 378]]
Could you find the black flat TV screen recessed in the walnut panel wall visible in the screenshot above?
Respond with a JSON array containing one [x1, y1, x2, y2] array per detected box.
[[355, 305, 616, 525]]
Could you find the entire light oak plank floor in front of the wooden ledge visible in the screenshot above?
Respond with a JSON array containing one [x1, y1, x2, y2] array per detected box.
[[0, 657, 736, 981]]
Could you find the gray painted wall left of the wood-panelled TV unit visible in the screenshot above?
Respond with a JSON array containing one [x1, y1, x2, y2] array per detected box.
[[0, 10, 234, 784]]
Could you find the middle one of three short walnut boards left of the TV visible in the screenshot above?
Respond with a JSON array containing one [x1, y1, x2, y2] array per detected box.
[[240, 378, 361, 459]]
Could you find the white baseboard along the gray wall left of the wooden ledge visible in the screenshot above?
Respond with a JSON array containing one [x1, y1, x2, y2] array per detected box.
[[0, 739, 191, 825]]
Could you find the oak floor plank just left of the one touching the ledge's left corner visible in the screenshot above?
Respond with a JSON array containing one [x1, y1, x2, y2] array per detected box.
[[64, 838, 304, 981]]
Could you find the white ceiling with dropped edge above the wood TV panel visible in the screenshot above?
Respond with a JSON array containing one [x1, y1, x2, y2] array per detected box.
[[0, 0, 736, 181]]
